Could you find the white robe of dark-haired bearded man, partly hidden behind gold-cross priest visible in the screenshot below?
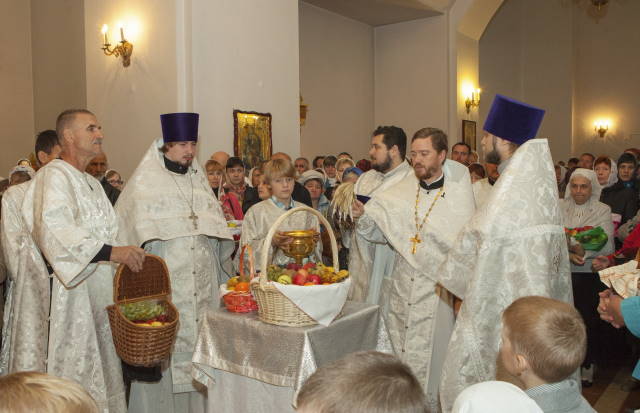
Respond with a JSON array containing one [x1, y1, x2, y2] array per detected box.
[[342, 161, 413, 301]]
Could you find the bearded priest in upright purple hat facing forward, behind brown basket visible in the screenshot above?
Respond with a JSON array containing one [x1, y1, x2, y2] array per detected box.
[[116, 113, 233, 413]]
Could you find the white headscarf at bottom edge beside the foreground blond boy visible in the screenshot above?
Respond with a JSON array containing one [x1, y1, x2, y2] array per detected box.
[[453, 381, 542, 413]]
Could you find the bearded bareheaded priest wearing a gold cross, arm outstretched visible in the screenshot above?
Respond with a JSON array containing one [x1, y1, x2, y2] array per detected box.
[[353, 128, 474, 412]]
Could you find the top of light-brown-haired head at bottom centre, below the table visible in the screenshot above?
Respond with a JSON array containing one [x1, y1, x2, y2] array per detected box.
[[297, 351, 427, 413]]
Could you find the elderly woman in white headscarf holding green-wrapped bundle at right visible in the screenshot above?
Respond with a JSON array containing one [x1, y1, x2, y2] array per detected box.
[[560, 168, 613, 386]]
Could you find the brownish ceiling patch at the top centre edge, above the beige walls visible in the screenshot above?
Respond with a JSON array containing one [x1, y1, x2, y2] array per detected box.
[[304, 0, 454, 26]]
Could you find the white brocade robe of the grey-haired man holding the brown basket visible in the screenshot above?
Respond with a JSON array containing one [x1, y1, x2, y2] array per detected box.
[[22, 159, 126, 413]]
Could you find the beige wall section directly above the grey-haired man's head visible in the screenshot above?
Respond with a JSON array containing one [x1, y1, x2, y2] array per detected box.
[[31, 0, 86, 132]]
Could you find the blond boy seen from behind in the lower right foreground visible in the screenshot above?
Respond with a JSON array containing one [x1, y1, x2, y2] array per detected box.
[[499, 296, 595, 413]]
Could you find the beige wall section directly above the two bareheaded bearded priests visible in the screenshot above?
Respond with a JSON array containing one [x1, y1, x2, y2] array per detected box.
[[374, 15, 449, 139]]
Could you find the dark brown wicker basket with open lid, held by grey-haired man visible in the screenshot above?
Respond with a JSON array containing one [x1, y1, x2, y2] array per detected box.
[[107, 254, 179, 367]]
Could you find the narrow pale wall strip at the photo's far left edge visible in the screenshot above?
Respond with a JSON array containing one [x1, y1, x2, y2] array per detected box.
[[0, 1, 34, 174]]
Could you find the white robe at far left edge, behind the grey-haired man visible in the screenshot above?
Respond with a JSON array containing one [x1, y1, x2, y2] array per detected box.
[[0, 181, 50, 374]]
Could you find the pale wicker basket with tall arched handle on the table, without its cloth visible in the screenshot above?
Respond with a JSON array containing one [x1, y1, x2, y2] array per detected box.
[[251, 206, 338, 327]]
